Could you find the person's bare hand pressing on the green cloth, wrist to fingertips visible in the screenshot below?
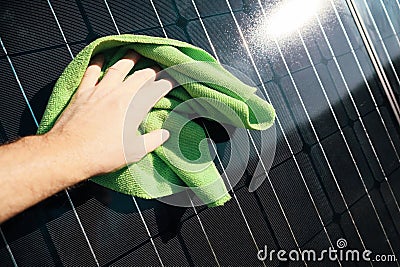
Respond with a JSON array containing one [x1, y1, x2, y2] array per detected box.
[[46, 51, 172, 177]]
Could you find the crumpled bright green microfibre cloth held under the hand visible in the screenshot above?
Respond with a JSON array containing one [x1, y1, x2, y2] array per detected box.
[[37, 34, 275, 206]]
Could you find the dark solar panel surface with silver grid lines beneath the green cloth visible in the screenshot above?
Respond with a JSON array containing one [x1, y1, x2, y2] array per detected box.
[[0, 0, 400, 266]]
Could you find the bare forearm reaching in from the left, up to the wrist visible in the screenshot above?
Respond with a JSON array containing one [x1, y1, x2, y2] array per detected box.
[[0, 135, 90, 222]]
